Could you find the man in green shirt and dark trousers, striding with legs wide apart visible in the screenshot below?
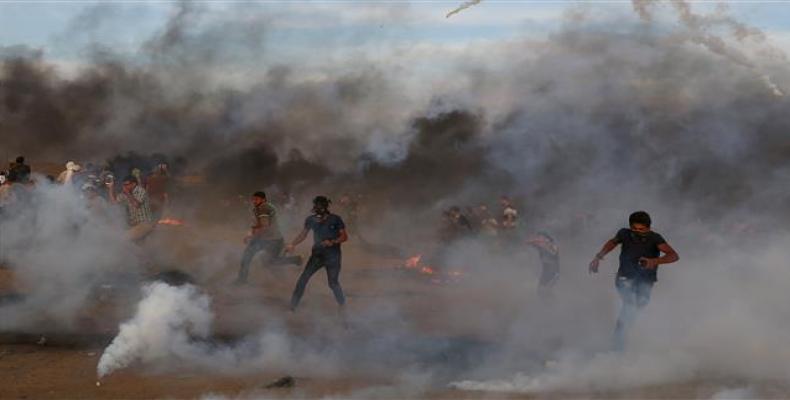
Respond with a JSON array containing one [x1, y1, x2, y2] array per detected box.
[[234, 192, 301, 285]]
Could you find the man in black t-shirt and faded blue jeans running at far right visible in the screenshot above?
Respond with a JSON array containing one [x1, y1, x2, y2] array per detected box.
[[590, 211, 679, 351]]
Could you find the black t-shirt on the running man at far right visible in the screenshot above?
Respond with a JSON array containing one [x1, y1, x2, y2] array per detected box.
[[614, 228, 666, 282]]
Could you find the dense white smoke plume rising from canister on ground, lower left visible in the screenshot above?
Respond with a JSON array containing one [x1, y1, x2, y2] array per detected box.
[[96, 282, 213, 378]]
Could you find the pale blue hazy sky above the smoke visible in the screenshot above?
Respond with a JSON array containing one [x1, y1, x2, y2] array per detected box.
[[0, 0, 790, 67]]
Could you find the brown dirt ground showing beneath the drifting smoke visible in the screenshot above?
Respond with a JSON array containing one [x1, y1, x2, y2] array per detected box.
[[0, 219, 790, 399]]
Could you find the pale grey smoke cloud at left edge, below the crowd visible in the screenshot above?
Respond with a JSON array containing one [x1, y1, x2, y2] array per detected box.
[[0, 181, 140, 330]]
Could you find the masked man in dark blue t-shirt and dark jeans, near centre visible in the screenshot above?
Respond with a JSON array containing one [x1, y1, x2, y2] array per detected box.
[[286, 196, 348, 312]]
